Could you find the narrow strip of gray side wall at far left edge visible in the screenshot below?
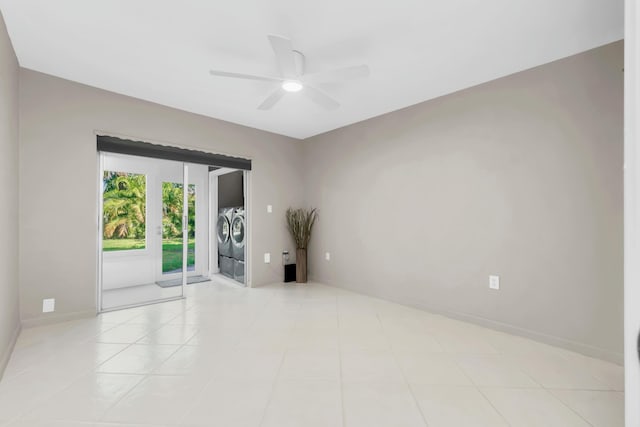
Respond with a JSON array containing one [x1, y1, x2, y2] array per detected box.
[[0, 14, 20, 375]]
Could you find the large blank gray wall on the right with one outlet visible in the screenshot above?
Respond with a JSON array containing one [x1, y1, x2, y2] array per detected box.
[[304, 42, 623, 361]]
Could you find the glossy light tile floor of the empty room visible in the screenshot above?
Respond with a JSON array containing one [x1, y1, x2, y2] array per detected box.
[[0, 282, 624, 427]]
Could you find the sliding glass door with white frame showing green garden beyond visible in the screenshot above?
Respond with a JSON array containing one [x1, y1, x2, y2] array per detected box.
[[100, 153, 188, 311]]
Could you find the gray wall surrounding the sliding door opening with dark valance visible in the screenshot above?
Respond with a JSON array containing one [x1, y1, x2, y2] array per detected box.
[[14, 69, 303, 323]]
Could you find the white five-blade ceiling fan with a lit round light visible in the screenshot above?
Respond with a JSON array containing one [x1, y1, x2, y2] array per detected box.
[[209, 35, 369, 110]]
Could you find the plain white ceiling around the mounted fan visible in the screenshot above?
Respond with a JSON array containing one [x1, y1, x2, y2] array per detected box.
[[0, 0, 624, 139]]
